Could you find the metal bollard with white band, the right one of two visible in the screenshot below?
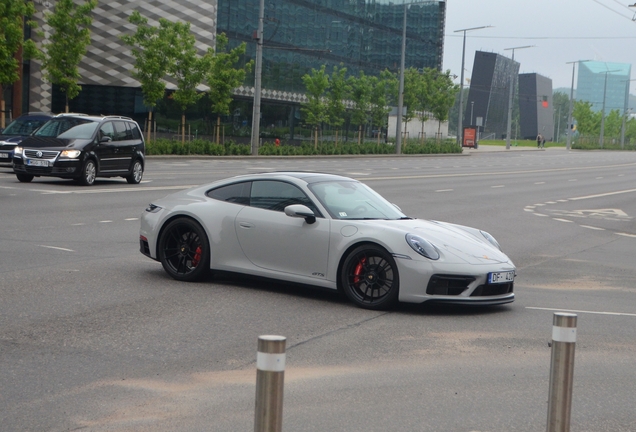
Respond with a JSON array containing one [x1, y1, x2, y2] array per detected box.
[[547, 312, 576, 432]]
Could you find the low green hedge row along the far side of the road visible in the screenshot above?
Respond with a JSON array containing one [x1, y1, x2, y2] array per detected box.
[[146, 139, 462, 156]]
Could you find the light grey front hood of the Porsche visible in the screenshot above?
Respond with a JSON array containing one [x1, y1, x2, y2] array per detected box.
[[364, 219, 512, 265]]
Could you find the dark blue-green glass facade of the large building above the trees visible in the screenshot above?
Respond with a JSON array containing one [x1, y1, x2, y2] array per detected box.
[[217, 0, 446, 93]]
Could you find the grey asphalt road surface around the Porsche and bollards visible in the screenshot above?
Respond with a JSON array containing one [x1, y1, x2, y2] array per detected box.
[[0, 149, 636, 432]]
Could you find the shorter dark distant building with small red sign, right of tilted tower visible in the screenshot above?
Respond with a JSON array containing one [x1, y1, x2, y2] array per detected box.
[[513, 73, 554, 141]]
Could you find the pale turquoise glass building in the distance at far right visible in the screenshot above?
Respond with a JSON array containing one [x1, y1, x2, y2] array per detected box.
[[576, 61, 632, 115]]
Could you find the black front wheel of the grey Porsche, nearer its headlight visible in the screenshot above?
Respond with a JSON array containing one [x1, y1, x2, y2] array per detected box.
[[340, 245, 400, 310]]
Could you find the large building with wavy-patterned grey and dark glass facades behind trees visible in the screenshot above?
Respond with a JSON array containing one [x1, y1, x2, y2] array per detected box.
[[21, 0, 446, 133]]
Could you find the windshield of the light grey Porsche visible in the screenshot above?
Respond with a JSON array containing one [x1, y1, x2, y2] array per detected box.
[[309, 180, 406, 219]]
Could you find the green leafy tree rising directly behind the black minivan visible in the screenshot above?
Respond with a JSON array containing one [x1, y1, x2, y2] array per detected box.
[[40, 0, 97, 112]]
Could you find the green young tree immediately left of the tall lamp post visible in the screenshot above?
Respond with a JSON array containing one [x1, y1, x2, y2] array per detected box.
[[205, 33, 253, 144]]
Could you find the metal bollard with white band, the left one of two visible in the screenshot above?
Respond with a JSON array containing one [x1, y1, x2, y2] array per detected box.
[[254, 336, 287, 432]]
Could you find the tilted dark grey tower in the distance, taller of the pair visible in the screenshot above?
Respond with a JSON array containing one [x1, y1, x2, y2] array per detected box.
[[464, 51, 519, 139]]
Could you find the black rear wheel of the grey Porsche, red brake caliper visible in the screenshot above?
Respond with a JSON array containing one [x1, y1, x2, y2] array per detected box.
[[158, 218, 210, 282]]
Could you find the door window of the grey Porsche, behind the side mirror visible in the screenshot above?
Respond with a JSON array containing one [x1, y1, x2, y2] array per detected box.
[[250, 180, 319, 215]]
